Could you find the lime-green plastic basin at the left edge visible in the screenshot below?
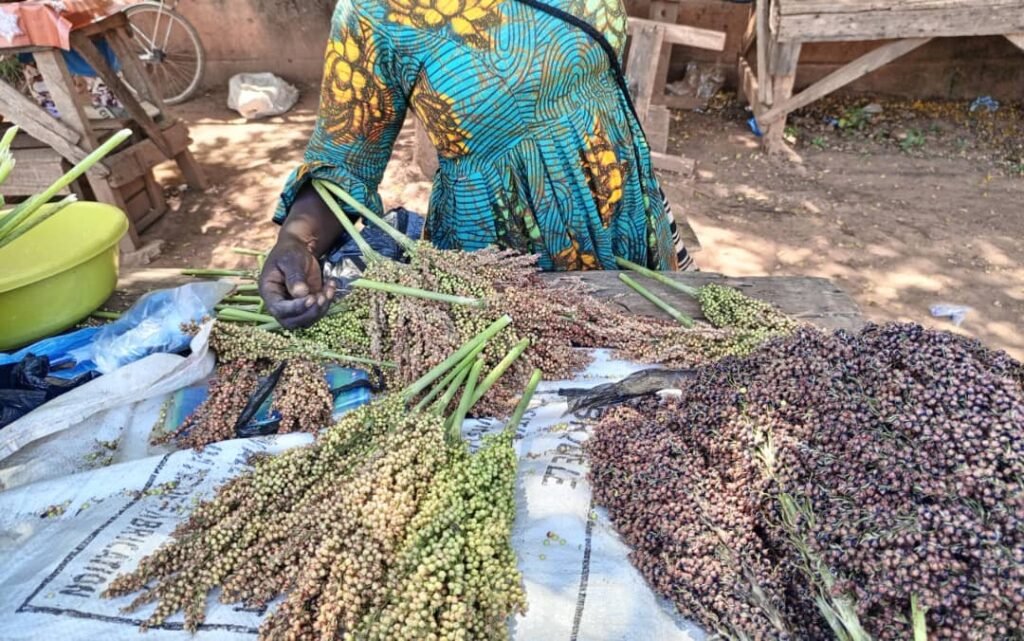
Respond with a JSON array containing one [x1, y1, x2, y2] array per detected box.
[[0, 203, 128, 351]]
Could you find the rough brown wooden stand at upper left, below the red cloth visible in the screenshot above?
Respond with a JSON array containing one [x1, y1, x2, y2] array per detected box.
[[0, 13, 206, 251]]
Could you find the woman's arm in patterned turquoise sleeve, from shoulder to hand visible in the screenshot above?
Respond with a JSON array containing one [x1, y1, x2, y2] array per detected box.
[[259, 0, 408, 329]]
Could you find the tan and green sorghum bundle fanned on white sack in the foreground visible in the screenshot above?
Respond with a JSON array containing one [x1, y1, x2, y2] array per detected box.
[[105, 318, 541, 641]]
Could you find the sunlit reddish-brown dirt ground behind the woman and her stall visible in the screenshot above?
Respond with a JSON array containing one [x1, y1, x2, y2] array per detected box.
[[143, 87, 1024, 358]]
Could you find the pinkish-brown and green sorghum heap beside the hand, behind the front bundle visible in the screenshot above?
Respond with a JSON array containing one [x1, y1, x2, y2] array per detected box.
[[292, 178, 796, 414]]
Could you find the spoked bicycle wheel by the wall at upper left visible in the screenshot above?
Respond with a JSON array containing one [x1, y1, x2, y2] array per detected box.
[[125, 2, 206, 104]]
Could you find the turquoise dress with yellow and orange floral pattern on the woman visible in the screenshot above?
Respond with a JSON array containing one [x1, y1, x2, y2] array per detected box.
[[274, 0, 678, 270]]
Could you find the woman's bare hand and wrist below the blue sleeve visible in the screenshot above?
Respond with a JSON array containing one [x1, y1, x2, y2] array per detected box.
[[259, 184, 341, 330]]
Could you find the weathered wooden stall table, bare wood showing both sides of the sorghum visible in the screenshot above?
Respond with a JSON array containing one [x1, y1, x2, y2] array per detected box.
[[112, 268, 864, 331]]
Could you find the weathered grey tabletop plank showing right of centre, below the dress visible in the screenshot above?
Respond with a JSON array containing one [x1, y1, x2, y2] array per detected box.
[[543, 271, 864, 331]]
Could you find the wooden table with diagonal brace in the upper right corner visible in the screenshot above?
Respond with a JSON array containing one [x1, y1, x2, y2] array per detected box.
[[739, 0, 1024, 152]]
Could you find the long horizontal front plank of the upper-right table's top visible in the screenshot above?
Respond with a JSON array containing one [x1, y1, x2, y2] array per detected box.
[[777, 6, 1024, 42]]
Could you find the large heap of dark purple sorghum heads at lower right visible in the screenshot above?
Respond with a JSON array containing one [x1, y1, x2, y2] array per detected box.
[[588, 325, 1024, 641]]
